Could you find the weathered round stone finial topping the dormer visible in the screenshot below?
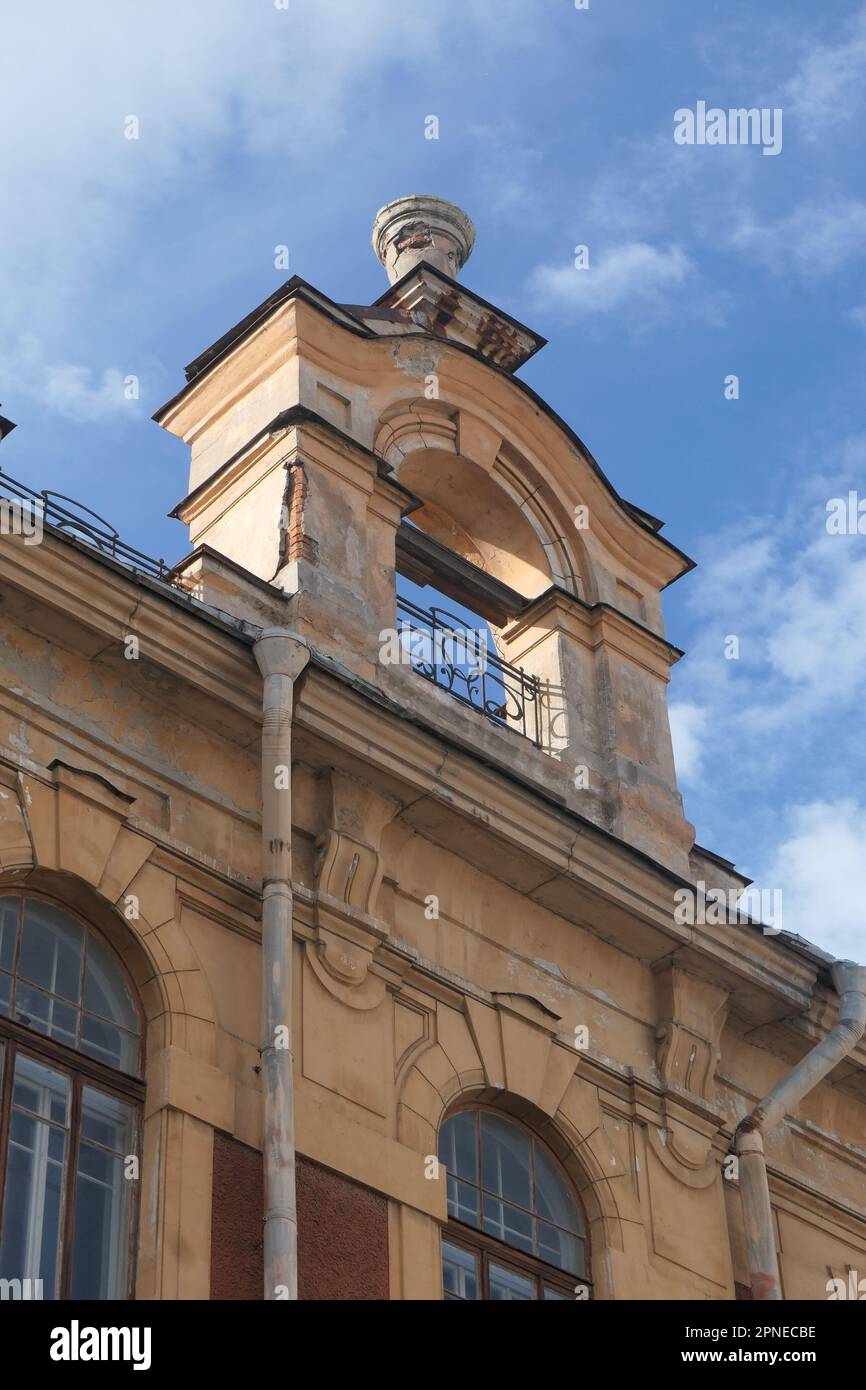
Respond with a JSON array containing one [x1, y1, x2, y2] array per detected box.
[[373, 193, 475, 285]]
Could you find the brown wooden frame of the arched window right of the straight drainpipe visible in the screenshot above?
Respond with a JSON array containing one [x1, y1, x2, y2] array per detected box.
[[436, 1104, 592, 1302]]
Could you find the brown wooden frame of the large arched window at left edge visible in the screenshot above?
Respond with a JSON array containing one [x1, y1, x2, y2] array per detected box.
[[0, 887, 146, 1302]]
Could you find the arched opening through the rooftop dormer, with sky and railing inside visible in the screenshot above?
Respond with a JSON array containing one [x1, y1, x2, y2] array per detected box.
[[377, 400, 594, 758]]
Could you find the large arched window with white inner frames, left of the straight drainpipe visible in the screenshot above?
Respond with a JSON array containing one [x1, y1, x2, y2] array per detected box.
[[0, 892, 145, 1298]]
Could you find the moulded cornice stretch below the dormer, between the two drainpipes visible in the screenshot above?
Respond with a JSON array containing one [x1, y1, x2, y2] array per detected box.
[[295, 666, 839, 1019]]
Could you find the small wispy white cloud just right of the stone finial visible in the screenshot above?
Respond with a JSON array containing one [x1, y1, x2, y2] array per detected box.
[[530, 242, 694, 316]]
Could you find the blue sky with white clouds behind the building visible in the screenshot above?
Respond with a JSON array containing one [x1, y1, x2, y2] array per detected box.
[[0, 0, 866, 959]]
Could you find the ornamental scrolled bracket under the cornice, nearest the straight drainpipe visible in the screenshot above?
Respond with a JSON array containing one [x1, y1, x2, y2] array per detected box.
[[307, 769, 400, 1009]]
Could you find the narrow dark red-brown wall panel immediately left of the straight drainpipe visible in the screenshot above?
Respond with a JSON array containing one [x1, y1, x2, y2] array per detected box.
[[210, 1130, 264, 1300]]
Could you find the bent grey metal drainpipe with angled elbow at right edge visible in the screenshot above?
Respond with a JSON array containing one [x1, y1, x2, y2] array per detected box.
[[734, 960, 866, 1301]]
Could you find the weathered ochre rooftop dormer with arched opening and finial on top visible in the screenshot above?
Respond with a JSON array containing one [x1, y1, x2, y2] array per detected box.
[[156, 196, 694, 876]]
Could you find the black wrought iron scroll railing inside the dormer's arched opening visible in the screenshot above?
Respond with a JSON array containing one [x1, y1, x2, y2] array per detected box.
[[398, 596, 542, 748]]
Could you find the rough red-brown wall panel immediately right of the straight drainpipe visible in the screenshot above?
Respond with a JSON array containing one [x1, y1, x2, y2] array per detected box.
[[297, 1155, 388, 1300]]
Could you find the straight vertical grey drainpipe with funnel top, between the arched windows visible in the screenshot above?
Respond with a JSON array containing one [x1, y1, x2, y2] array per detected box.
[[253, 627, 310, 1300]]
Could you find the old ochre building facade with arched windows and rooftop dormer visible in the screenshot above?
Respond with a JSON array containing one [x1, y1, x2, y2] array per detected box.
[[0, 199, 866, 1300]]
